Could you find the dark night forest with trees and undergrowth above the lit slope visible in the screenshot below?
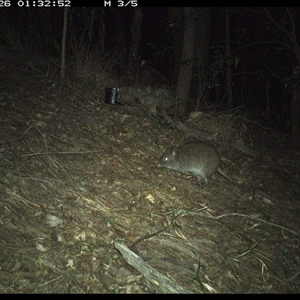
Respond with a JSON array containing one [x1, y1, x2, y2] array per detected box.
[[0, 7, 300, 147]]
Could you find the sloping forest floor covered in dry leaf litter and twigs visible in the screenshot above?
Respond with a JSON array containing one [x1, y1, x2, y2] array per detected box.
[[0, 58, 300, 293]]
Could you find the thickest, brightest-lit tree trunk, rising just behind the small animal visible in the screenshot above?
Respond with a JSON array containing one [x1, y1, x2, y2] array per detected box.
[[176, 7, 195, 116]]
